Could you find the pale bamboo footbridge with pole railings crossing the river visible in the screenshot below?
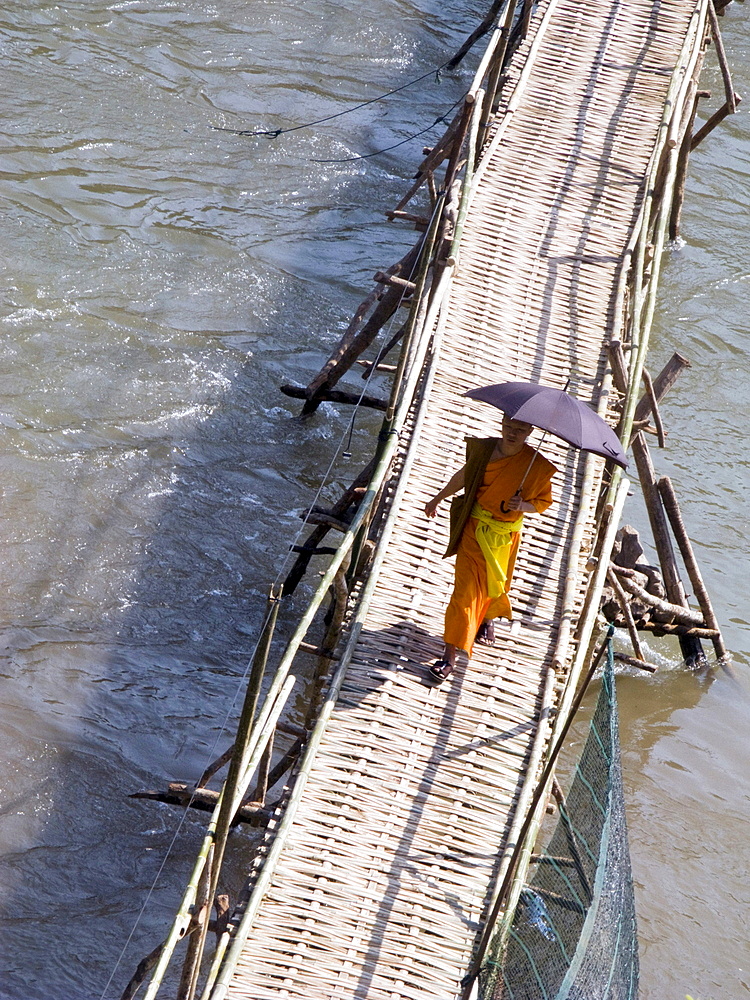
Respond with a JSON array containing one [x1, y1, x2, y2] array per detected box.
[[132, 0, 734, 1000]]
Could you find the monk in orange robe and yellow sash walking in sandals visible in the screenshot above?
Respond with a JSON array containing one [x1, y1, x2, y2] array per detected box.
[[424, 414, 557, 682]]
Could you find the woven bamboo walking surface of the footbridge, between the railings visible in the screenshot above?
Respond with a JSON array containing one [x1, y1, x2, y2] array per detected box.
[[213, 0, 694, 1000]]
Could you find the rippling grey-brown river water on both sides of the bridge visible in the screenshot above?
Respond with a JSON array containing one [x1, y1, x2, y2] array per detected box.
[[0, 0, 750, 1000]]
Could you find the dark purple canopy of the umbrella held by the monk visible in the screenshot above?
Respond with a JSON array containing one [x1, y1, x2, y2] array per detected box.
[[464, 382, 628, 469]]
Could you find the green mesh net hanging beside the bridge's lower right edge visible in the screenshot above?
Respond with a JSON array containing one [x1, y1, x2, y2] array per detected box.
[[479, 644, 638, 1000]]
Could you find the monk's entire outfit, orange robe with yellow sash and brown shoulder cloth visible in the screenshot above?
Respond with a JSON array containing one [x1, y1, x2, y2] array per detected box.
[[445, 438, 556, 656]]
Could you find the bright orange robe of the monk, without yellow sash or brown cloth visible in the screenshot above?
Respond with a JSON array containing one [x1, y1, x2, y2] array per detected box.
[[444, 444, 557, 656]]
